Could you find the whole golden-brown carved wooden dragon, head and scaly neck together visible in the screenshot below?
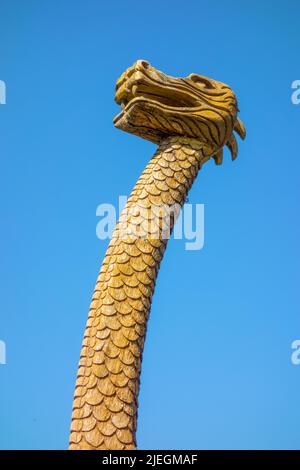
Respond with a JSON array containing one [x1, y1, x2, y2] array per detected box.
[[70, 60, 245, 450]]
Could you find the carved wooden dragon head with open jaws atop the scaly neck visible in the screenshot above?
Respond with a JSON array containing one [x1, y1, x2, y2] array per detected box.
[[114, 60, 246, 164]]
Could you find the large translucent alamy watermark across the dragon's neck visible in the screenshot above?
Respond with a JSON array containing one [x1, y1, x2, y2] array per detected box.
[[96, 196, 204, 250]]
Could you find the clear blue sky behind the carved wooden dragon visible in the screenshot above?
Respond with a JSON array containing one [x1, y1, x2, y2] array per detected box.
[[0, 0, 300, 449]]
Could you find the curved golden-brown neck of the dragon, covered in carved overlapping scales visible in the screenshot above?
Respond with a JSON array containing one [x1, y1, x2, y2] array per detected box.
[[70, 137, 213, 450]]
